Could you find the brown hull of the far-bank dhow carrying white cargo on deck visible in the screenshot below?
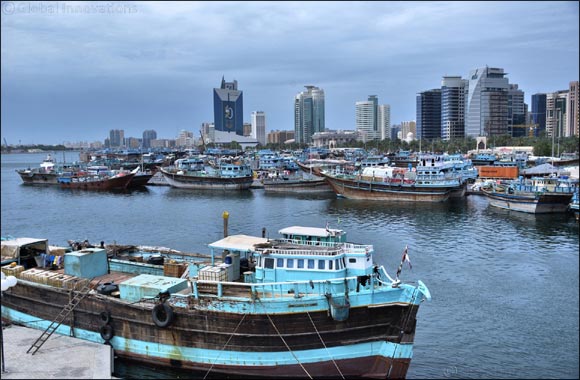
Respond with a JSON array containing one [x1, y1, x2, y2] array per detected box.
[[325, 175, 454, 202]]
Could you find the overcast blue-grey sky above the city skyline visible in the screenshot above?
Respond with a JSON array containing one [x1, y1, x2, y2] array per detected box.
[[0, 1, 580, 145]]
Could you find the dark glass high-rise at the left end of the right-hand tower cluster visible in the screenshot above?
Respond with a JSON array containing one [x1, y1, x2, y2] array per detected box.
[[414, 88, 441, 139]]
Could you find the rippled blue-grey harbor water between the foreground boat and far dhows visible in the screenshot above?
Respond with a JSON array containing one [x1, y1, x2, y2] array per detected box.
[[1, 152, 579, 379]]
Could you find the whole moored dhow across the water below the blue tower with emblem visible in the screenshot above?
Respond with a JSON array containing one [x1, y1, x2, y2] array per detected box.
[[159, 161, 254, 190]]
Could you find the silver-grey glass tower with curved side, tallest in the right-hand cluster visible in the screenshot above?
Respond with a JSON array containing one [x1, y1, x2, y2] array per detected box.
[[465, 66, 509, 137]]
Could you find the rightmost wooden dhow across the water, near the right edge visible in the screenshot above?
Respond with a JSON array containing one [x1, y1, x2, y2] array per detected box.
[[481, 177, 578, 214]]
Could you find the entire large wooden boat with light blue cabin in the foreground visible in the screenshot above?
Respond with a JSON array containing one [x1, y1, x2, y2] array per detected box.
[[2, 226, 430, 379]]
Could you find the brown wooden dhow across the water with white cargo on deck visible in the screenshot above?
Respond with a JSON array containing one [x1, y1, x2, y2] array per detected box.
[[322, 167, 466, 202]]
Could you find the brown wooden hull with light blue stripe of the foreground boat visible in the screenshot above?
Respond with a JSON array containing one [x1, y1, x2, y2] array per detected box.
[[2, 280, 420, 379]]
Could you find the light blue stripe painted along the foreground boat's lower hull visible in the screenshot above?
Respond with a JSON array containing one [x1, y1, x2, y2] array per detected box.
[[2, 306, 413, 366]]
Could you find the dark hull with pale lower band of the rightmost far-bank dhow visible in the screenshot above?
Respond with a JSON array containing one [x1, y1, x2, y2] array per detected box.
[[482, 189, 572, 214]]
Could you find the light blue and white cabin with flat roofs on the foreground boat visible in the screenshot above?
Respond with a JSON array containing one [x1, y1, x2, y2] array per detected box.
[[202, 226, 374, 283]]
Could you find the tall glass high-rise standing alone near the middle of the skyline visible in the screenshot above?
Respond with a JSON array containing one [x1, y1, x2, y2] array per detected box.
[[294, 86, 325, 144]]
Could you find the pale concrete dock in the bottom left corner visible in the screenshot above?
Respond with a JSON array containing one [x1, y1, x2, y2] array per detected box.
[[1, 325, 113, 379]]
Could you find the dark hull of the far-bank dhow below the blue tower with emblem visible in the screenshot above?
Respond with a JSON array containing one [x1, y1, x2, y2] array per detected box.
[[160, 168, 254, 190]]
